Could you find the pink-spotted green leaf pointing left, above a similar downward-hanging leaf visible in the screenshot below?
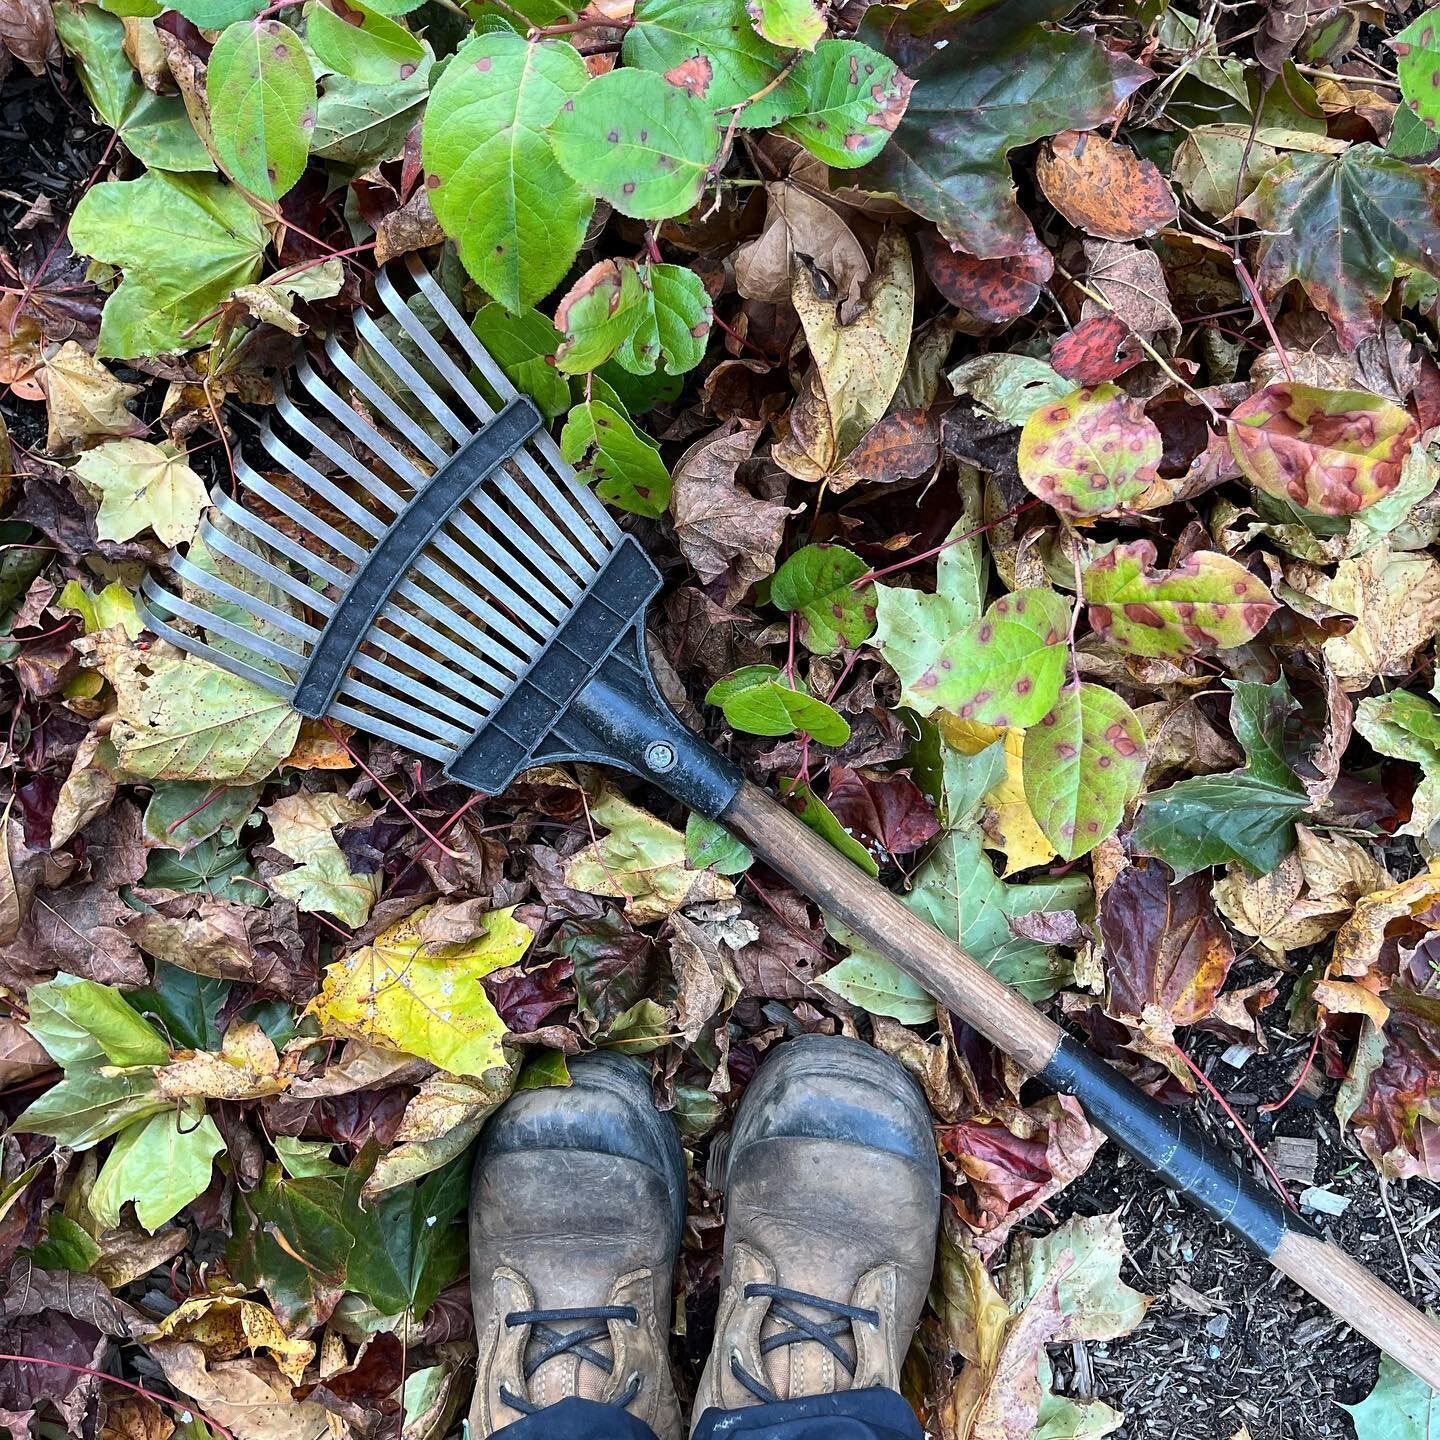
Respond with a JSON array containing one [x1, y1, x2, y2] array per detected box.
[[910, 589, 1070, 729]]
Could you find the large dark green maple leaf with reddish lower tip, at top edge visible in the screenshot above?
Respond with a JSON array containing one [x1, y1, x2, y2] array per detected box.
[[855, 0, 1151, 258]]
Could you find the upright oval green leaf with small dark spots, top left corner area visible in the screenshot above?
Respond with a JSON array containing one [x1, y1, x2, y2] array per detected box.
[[204, 19, 317, 204]]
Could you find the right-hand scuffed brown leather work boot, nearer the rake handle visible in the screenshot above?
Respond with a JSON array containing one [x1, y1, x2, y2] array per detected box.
[[694, 1035, 940, 1421]]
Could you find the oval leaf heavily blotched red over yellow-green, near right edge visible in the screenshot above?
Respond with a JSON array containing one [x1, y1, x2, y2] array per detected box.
[[1230, 384, 1420, 516]]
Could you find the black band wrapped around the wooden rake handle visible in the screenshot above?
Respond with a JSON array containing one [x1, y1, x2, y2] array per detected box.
[[1035, 1035, 1313, 1259]]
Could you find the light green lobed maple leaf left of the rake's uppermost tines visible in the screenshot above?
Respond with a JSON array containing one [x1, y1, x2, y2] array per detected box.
[[69, 170, 266, 359]]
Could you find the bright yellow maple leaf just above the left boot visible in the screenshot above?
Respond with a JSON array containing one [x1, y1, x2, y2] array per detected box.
[[305, 906, 534, 1079]]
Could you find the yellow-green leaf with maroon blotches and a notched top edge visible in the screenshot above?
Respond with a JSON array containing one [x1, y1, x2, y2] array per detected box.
[[1084, 540, 1277, 655]]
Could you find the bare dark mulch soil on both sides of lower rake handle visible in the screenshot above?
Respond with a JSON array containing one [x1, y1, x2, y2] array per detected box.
[[1035, 962, 1440, 1440]]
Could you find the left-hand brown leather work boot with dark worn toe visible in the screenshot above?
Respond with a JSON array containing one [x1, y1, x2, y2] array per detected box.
[[469, 1054, 685, 1440]]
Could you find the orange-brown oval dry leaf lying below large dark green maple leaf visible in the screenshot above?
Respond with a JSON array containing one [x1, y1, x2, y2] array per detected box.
[[1035, 130, 1175, 240]]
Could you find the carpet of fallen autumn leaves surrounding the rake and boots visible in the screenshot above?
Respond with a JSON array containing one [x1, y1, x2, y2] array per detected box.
[[8, 0, 1440, 1440]]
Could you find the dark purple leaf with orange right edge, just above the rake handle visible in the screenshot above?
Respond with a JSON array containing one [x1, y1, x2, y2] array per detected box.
[[1100, 861, 1236, 1041]]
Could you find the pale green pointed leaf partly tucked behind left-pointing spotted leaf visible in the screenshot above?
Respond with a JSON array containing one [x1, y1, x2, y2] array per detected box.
[[873, 495, 986, 716]]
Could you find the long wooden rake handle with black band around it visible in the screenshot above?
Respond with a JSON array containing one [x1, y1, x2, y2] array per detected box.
[[720, 782, 1440, 1390]]
